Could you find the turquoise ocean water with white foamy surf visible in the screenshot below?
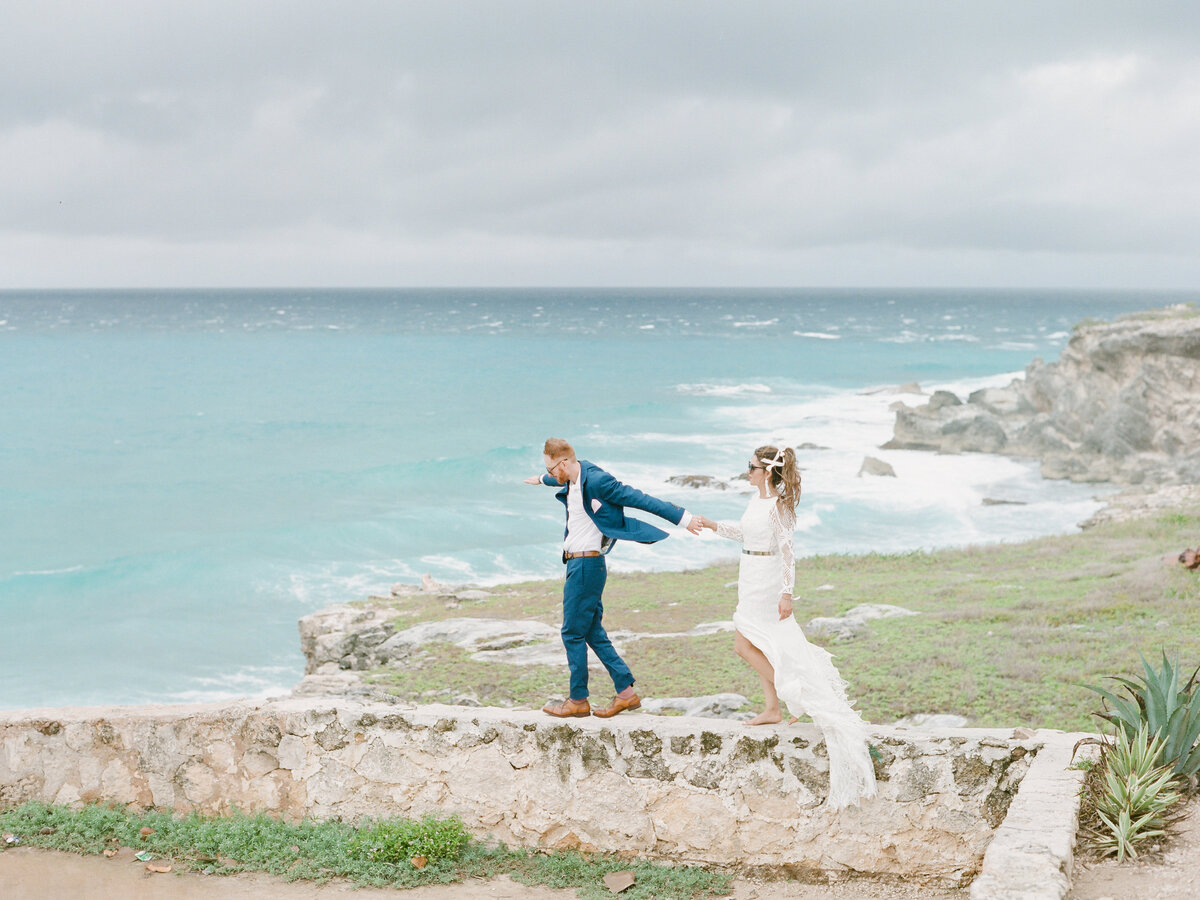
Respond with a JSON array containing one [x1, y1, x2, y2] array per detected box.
[[0, 289, 1200, 708]]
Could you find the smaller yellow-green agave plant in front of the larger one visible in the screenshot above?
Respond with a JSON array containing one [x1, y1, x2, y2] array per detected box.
[[1090, 725, 1180, 863]]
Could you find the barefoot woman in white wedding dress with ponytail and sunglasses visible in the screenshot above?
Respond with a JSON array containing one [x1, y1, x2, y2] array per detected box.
[[700, 446, 875, 809]]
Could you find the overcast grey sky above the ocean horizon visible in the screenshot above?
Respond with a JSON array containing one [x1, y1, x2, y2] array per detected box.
[[0, 0, 1200, 288]]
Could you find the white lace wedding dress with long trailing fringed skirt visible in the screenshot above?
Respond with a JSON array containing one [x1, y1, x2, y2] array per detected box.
[[716, 497, 875, 809]]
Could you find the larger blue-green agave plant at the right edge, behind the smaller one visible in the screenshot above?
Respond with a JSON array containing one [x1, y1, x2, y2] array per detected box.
[[1084, 650, 1200, 787]]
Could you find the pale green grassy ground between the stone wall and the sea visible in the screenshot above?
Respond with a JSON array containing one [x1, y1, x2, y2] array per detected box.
[[362, 509, 1200, 731]]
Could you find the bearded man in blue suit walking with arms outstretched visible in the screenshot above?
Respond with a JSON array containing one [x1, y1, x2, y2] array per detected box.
[[526, 438, 700, 719]]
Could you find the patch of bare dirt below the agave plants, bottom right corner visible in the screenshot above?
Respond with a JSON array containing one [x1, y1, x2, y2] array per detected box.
[[1067, 800, 1200, 900]]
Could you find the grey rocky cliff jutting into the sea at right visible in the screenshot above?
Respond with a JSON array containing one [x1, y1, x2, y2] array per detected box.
[[884, 306, 1200, 485]]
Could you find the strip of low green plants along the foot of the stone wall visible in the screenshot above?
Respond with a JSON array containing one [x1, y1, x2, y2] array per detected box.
[[0, 803, 730, 900]]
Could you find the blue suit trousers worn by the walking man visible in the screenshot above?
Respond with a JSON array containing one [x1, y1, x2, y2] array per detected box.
[[563, 557, 634, 700]]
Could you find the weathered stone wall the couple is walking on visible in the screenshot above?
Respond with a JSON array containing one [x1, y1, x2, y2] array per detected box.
[[0, 698, 1055, 882]]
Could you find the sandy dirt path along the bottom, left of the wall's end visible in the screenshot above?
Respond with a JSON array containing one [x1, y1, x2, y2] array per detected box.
[[0, 847, 966, 900]]
